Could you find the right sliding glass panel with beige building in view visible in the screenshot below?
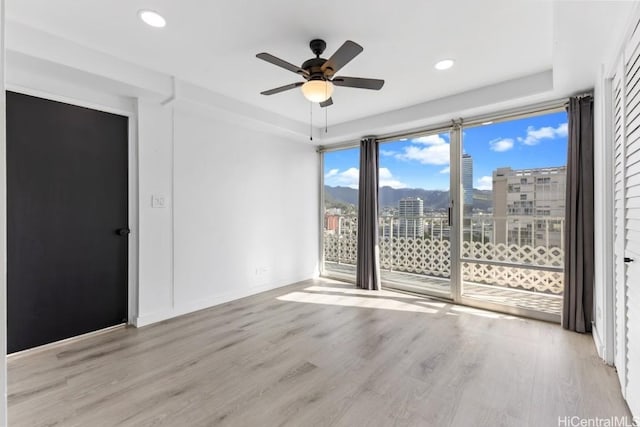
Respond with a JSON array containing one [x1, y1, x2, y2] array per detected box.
[[460, 110, 567, 320]]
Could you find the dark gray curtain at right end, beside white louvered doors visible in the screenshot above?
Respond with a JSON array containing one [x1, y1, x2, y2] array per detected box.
[[562, 96, 594, 332]]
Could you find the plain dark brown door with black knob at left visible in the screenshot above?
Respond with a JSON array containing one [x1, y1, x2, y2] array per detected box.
[[7, 92, 128, 353]]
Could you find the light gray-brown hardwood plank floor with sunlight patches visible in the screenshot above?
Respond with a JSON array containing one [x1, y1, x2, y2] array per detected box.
[[8, 280, 630, 427]]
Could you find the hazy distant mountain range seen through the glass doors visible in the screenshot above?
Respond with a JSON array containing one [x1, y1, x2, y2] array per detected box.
[[324, 185, 492, 211]]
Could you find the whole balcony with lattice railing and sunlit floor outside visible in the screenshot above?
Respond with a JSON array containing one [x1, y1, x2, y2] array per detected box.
[[324, 214, 564, 316]]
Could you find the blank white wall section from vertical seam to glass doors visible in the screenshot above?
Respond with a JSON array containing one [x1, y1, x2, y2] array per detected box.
[[174, 111, 319, 314]]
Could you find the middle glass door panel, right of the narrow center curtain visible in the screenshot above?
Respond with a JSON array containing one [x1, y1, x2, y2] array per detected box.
[[379, 132, 455, 298]]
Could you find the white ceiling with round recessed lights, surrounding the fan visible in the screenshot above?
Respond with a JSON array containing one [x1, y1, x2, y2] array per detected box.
[[7, 0, 630, 135]]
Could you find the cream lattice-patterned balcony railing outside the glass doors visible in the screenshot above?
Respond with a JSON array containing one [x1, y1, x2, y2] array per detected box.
[[324, 215, 564, 295]]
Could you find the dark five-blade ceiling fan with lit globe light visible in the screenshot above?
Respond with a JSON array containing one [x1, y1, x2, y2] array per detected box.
[[256, 39, 384, 107]]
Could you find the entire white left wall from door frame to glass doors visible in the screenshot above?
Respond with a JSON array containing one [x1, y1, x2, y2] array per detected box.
[[137, 101, 319, 326]]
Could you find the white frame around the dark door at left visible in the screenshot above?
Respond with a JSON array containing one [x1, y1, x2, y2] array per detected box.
[[5, 87, 139, 325]]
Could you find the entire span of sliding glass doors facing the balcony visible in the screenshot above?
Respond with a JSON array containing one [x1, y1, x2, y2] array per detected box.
[[322, 109, 567, 321]]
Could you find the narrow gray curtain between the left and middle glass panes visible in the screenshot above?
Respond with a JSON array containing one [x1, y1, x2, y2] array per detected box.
[[356, 138, 380, 290]]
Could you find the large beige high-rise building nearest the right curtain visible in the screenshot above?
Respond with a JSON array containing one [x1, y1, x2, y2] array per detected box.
[[493, 166, 567, 247]]
